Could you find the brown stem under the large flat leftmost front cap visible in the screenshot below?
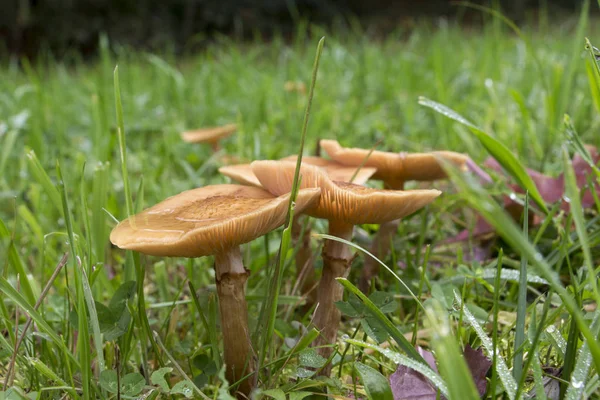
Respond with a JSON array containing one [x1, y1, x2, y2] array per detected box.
[[215, 246, 256, 398]]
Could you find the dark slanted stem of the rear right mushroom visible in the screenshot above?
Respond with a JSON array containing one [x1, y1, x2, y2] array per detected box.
[[358, 181, 404, 293]]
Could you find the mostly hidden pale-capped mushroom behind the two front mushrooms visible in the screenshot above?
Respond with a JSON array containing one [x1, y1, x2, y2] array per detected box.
[[219, 155, 376, 304]]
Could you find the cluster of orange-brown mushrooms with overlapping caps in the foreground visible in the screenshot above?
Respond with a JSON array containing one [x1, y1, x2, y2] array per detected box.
[[110, 130, 466, 396]]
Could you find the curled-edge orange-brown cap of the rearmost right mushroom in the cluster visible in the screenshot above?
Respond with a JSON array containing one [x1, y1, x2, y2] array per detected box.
[[320, 140, 468, 182]]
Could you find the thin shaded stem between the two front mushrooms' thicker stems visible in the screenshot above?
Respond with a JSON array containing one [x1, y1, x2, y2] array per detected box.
[[292, 215, 316, 306]]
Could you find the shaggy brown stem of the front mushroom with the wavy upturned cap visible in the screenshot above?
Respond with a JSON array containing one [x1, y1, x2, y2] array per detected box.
[[314, 221, 354, 376]]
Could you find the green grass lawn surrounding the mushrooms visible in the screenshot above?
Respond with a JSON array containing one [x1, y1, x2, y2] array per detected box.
[[0, 10, 600, 400]]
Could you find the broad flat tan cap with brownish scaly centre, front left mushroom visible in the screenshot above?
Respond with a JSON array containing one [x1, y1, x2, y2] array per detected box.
[[110, 185, 320, 257]]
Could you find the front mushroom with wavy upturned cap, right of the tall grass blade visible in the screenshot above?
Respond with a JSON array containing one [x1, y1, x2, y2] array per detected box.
[[252, 161, 441, 374]]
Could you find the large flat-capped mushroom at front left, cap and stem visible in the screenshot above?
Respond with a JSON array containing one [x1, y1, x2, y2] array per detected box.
[[110, 185, 320, 396]]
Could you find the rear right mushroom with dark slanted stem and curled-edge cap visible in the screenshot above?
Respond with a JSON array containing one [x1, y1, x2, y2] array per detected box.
[[320, 139, 469, 293]]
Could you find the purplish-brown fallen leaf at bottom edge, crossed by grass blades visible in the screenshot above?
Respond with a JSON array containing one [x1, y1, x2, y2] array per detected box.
[[390, 345, 492, 400]]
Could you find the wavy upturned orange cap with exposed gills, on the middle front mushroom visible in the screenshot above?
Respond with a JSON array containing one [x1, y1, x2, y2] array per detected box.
[[251, 161, 441, 225]]
